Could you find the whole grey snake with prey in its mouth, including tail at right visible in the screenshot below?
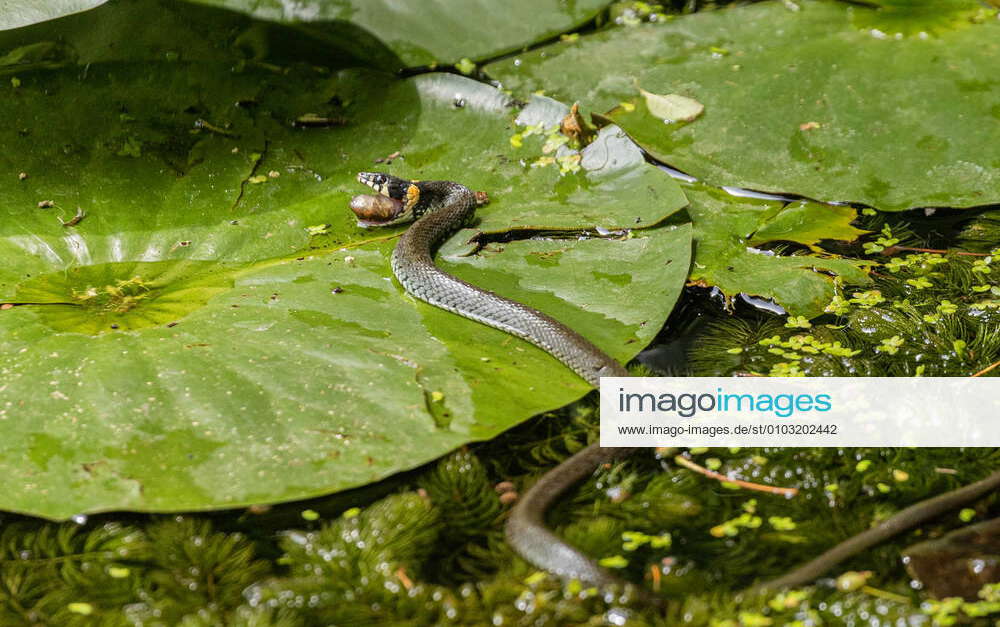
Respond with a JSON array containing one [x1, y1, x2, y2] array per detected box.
[[351, 172, 1000, 590]]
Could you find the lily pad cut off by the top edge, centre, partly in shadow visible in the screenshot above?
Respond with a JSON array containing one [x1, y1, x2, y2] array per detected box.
[[184, 0, 609, 69]]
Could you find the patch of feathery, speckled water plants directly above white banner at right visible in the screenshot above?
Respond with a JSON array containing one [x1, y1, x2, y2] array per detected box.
[[691, 239, 1000, 377]]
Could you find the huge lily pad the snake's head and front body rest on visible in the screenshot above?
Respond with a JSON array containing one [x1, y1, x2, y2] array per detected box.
[[0, 11, 691, 518]]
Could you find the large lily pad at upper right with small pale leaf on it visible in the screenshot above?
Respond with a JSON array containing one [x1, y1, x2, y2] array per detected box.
[[486, 1, 1000, 211]]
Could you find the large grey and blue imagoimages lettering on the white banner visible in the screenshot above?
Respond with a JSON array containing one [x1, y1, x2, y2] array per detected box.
[[618, 387, 833, 418]]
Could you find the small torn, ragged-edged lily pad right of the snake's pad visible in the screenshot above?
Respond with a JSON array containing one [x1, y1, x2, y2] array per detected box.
[[684, 183, 871, 318]]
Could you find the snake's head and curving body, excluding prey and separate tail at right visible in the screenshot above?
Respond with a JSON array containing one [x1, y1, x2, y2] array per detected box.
[[358, 173, 635, 585]]
